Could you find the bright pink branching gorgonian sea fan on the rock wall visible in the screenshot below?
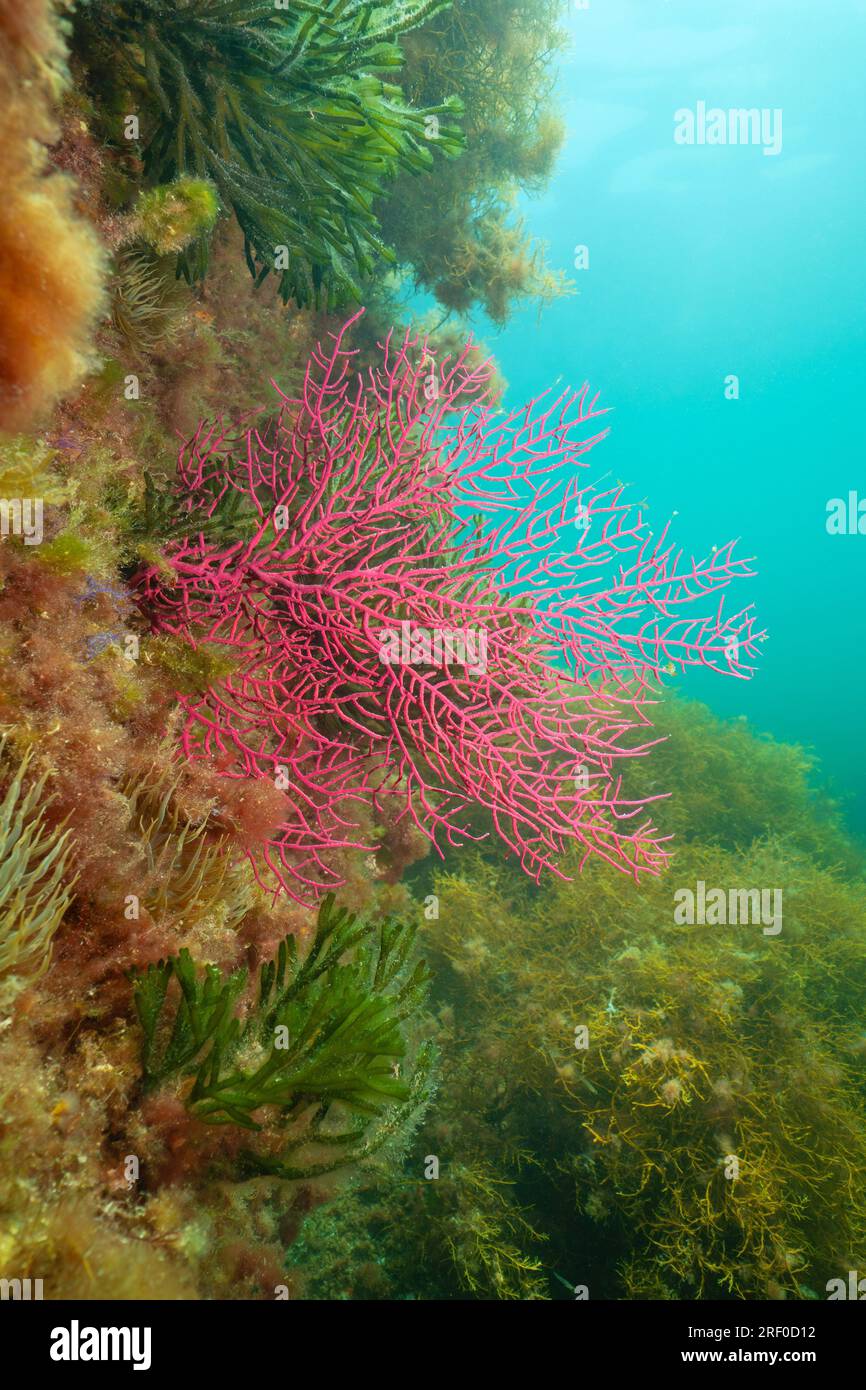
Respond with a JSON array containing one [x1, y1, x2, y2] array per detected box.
[[136, 311, 762, 901]]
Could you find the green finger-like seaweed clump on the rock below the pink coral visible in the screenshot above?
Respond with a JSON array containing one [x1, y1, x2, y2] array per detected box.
[[133, 897, 432, 1179]]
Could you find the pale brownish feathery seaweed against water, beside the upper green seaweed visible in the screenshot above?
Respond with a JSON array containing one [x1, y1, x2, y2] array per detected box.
[[378, 0, 571, 322]]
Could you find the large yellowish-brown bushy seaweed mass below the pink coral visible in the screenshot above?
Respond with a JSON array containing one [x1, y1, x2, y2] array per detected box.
[[284, 701, 866, 1300]]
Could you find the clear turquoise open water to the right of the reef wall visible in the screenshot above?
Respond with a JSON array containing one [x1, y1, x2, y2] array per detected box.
[[477, 0, 866, 831]]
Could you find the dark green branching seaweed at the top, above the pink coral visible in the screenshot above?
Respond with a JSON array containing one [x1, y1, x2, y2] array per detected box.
[[81, 0, 459, 304]]
